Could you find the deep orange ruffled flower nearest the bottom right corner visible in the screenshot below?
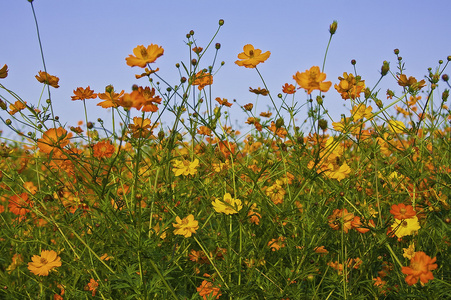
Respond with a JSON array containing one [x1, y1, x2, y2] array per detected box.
[[401, 251, 437, 285]]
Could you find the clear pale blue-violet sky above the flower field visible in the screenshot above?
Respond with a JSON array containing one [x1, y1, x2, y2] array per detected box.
[[0, 0, 451, 137]]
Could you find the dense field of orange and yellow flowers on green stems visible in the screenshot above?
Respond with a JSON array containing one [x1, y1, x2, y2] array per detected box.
[[0, 3, 451, 299]]
